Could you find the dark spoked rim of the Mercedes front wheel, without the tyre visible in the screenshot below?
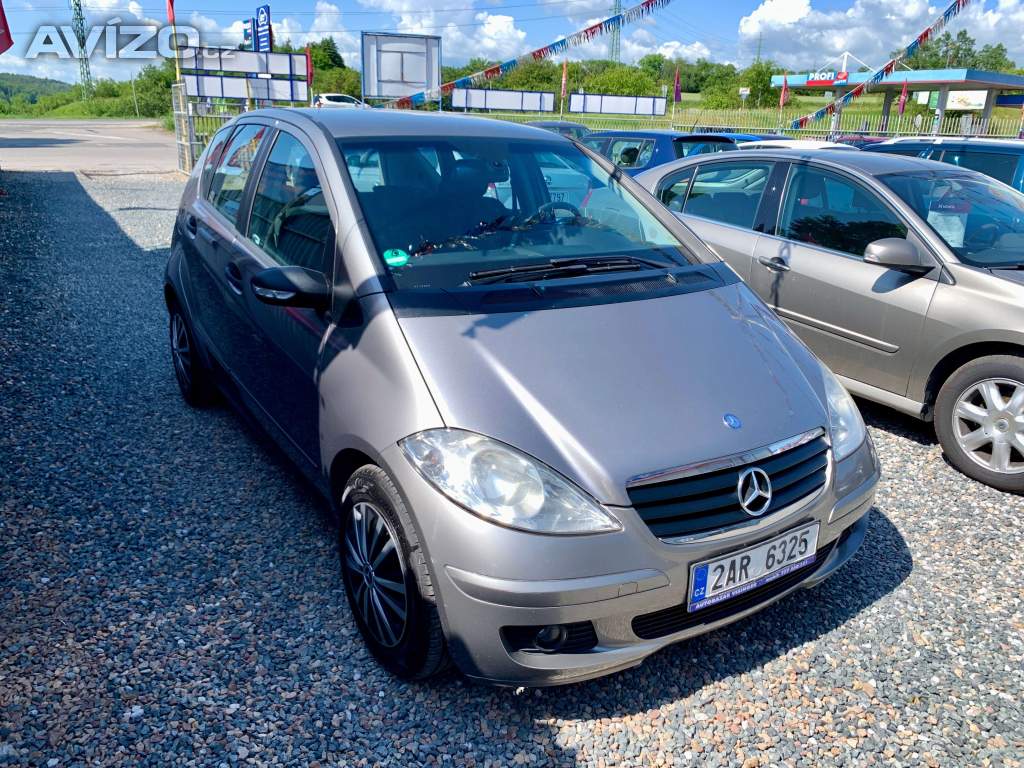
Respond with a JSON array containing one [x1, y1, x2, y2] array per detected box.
[[344, 502, 409, 648]]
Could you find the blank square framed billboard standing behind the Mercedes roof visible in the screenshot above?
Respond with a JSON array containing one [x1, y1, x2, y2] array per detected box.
[[362, 32, 441, 99]]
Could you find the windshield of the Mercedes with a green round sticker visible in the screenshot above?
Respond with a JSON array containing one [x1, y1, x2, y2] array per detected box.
[[339, 137, 696, 290]]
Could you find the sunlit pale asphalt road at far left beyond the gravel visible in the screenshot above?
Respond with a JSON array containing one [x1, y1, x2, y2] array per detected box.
[[0, 120, 176, 173]]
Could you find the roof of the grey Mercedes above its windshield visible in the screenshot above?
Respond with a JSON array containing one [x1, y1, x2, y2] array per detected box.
[[254, 108, 571, 143]]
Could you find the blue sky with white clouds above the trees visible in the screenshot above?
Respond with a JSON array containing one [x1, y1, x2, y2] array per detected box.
[[0, 0, 1024, 82]]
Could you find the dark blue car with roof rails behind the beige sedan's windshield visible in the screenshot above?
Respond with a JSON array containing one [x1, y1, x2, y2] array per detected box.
[[865, 136, 1024, 191]]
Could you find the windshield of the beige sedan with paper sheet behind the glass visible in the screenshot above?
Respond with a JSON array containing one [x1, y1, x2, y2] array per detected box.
[[880, 172, 1024, 267]]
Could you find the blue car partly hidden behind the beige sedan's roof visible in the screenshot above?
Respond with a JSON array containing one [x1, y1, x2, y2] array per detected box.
[[581, 130, 787, 176]]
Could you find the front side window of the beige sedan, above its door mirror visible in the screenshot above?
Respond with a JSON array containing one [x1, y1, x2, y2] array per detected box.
[[778, 166, 906, 256]]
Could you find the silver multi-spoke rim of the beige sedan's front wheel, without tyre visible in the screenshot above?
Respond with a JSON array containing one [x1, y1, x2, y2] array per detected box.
[[952, 379, 1024, 474]]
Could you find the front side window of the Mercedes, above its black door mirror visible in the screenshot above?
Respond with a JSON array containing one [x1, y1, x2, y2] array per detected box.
[[248, 131, 334, 276]]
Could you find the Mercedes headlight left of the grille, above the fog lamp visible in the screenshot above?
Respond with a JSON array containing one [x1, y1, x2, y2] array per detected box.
[[399, 429, 622, 534]]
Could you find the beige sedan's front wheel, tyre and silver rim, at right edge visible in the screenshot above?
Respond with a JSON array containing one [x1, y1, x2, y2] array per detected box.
[[935, 354, 1024, 494]]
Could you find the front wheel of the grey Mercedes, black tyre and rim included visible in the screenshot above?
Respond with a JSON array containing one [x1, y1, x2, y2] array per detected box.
[[338, 465, 450, 680]]
